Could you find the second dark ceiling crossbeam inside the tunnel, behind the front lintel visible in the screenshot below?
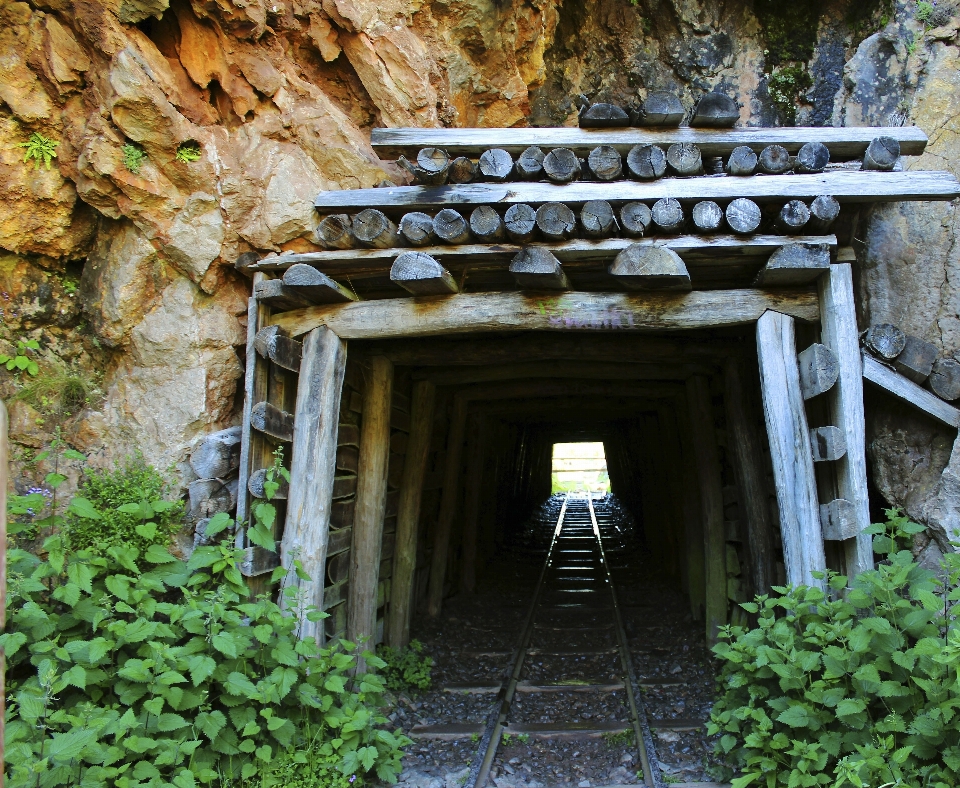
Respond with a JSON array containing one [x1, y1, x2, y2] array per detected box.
[[412, 361, 715, 386]]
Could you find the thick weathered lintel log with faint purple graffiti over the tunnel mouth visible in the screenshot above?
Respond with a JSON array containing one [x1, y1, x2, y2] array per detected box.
[[271, 290, 820, 339]]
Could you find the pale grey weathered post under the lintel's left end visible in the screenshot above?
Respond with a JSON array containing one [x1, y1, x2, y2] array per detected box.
[[280, 326, 347, 642]]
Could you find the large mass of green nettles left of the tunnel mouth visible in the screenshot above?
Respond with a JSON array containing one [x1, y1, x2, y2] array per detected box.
[[0, 452, 409, 788]]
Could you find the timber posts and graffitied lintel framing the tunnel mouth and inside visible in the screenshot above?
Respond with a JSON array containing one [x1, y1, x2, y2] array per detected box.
[[238, 263, 893, 644]]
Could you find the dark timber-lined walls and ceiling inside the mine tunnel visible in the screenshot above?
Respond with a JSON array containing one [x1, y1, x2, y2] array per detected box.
[[325, 326, 864, 639]]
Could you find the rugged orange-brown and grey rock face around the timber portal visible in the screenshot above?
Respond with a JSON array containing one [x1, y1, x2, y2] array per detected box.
[[0, 0, 960, 548]]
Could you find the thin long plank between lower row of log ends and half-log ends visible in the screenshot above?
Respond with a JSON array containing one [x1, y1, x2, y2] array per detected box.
[[251, 235, 837, 276]]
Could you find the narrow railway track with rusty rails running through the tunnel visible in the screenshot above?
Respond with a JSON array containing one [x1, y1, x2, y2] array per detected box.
[[470, 495, 663, 788]]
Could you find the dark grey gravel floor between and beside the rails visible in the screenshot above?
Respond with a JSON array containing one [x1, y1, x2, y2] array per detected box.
[[392, 499, 714, 788]]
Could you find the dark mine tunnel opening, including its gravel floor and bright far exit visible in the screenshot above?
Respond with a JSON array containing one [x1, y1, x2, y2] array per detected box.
[[316, 327, 804, 784]]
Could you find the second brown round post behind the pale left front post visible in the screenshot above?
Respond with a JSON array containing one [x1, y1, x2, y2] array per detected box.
[[386, 380, 437, 648]]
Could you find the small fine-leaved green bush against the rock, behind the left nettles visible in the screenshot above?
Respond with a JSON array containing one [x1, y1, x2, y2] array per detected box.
[[63, 454, 183, 554]]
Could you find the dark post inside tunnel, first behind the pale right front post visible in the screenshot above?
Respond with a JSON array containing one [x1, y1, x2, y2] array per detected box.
[[723, 358, 774, 594]]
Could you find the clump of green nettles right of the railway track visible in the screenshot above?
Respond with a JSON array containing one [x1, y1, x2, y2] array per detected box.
[[708, 510, 960, 788]]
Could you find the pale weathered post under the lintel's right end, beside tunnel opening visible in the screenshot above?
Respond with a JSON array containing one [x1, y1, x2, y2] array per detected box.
[[757, 312, 826, 585]]
